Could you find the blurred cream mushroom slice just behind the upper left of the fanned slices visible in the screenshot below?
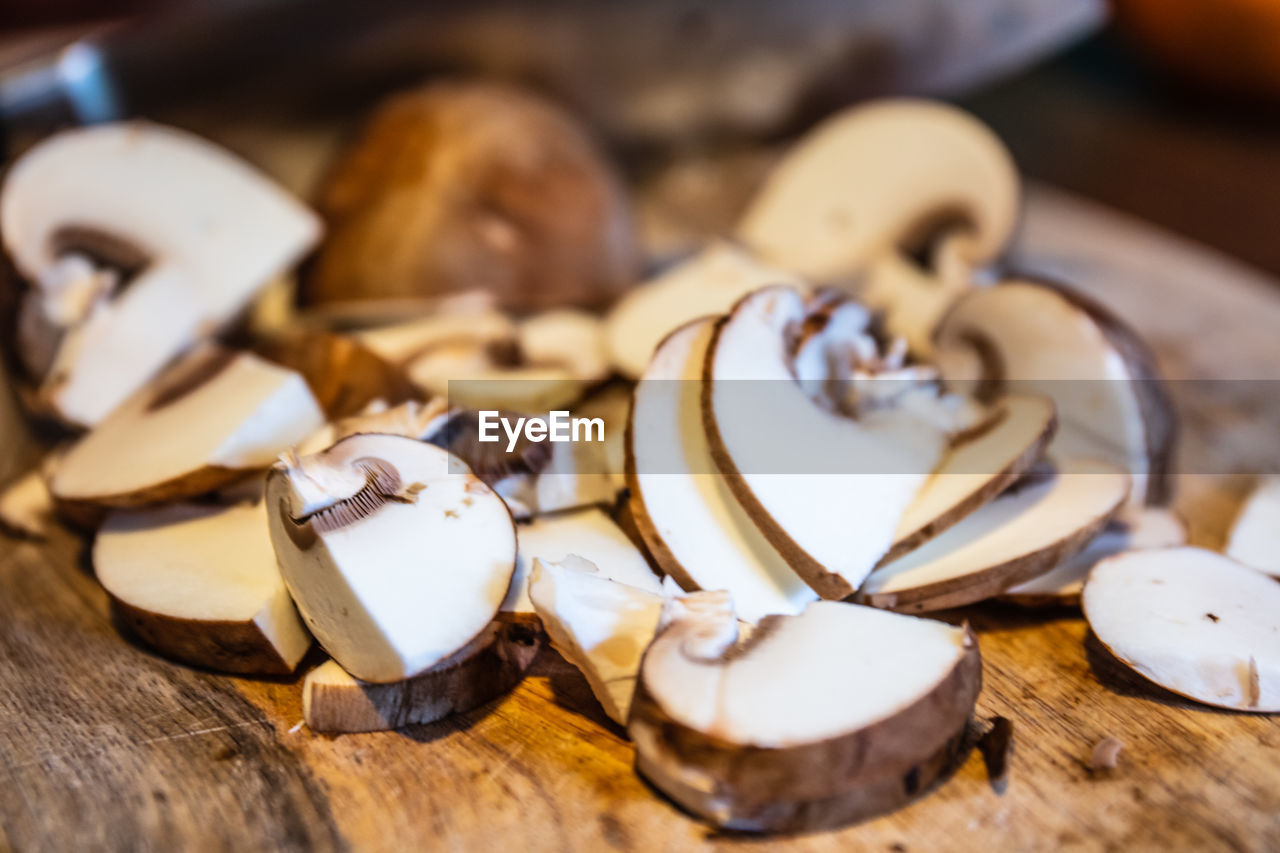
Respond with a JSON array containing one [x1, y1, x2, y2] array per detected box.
[[605, 241, 803, 379]]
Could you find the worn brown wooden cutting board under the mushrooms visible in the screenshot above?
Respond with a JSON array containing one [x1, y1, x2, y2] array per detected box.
[[0, 183, 1280, 850]]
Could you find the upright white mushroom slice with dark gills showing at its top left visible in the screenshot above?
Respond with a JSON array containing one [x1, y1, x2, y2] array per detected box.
[[266, 434, 516, 684]]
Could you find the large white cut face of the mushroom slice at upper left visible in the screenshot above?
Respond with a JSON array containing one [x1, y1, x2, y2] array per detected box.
[[0, 122, 320, 427]]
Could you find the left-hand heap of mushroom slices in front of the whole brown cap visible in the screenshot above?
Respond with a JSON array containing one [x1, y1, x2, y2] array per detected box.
[[0, 124, 634, 730]]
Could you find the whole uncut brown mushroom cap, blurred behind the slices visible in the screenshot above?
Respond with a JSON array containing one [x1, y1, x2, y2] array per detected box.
[[298, 82, 636, 311]]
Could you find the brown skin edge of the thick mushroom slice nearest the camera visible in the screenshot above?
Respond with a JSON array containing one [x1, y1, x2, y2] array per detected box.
[[627, 617, 982, 831]]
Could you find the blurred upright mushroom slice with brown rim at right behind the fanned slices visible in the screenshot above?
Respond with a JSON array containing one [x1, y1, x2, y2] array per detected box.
[[936, 279, 1176, 505]]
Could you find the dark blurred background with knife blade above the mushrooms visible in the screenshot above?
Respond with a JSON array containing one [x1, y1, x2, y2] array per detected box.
[[0, 0, 1280, 273]]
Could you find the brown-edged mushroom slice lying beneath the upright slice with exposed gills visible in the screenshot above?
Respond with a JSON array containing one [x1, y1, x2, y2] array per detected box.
[[302, 622, 544, 733]]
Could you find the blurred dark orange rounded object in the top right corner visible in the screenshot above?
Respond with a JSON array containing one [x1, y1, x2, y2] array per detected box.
[[1112, 0, 1280, 99]]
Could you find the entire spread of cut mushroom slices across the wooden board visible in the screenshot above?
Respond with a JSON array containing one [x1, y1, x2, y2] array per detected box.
[[0, 101, 1280, 831]]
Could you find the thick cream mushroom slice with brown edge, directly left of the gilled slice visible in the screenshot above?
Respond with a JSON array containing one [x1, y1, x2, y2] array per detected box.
[[93, 503, 311, 675]]
